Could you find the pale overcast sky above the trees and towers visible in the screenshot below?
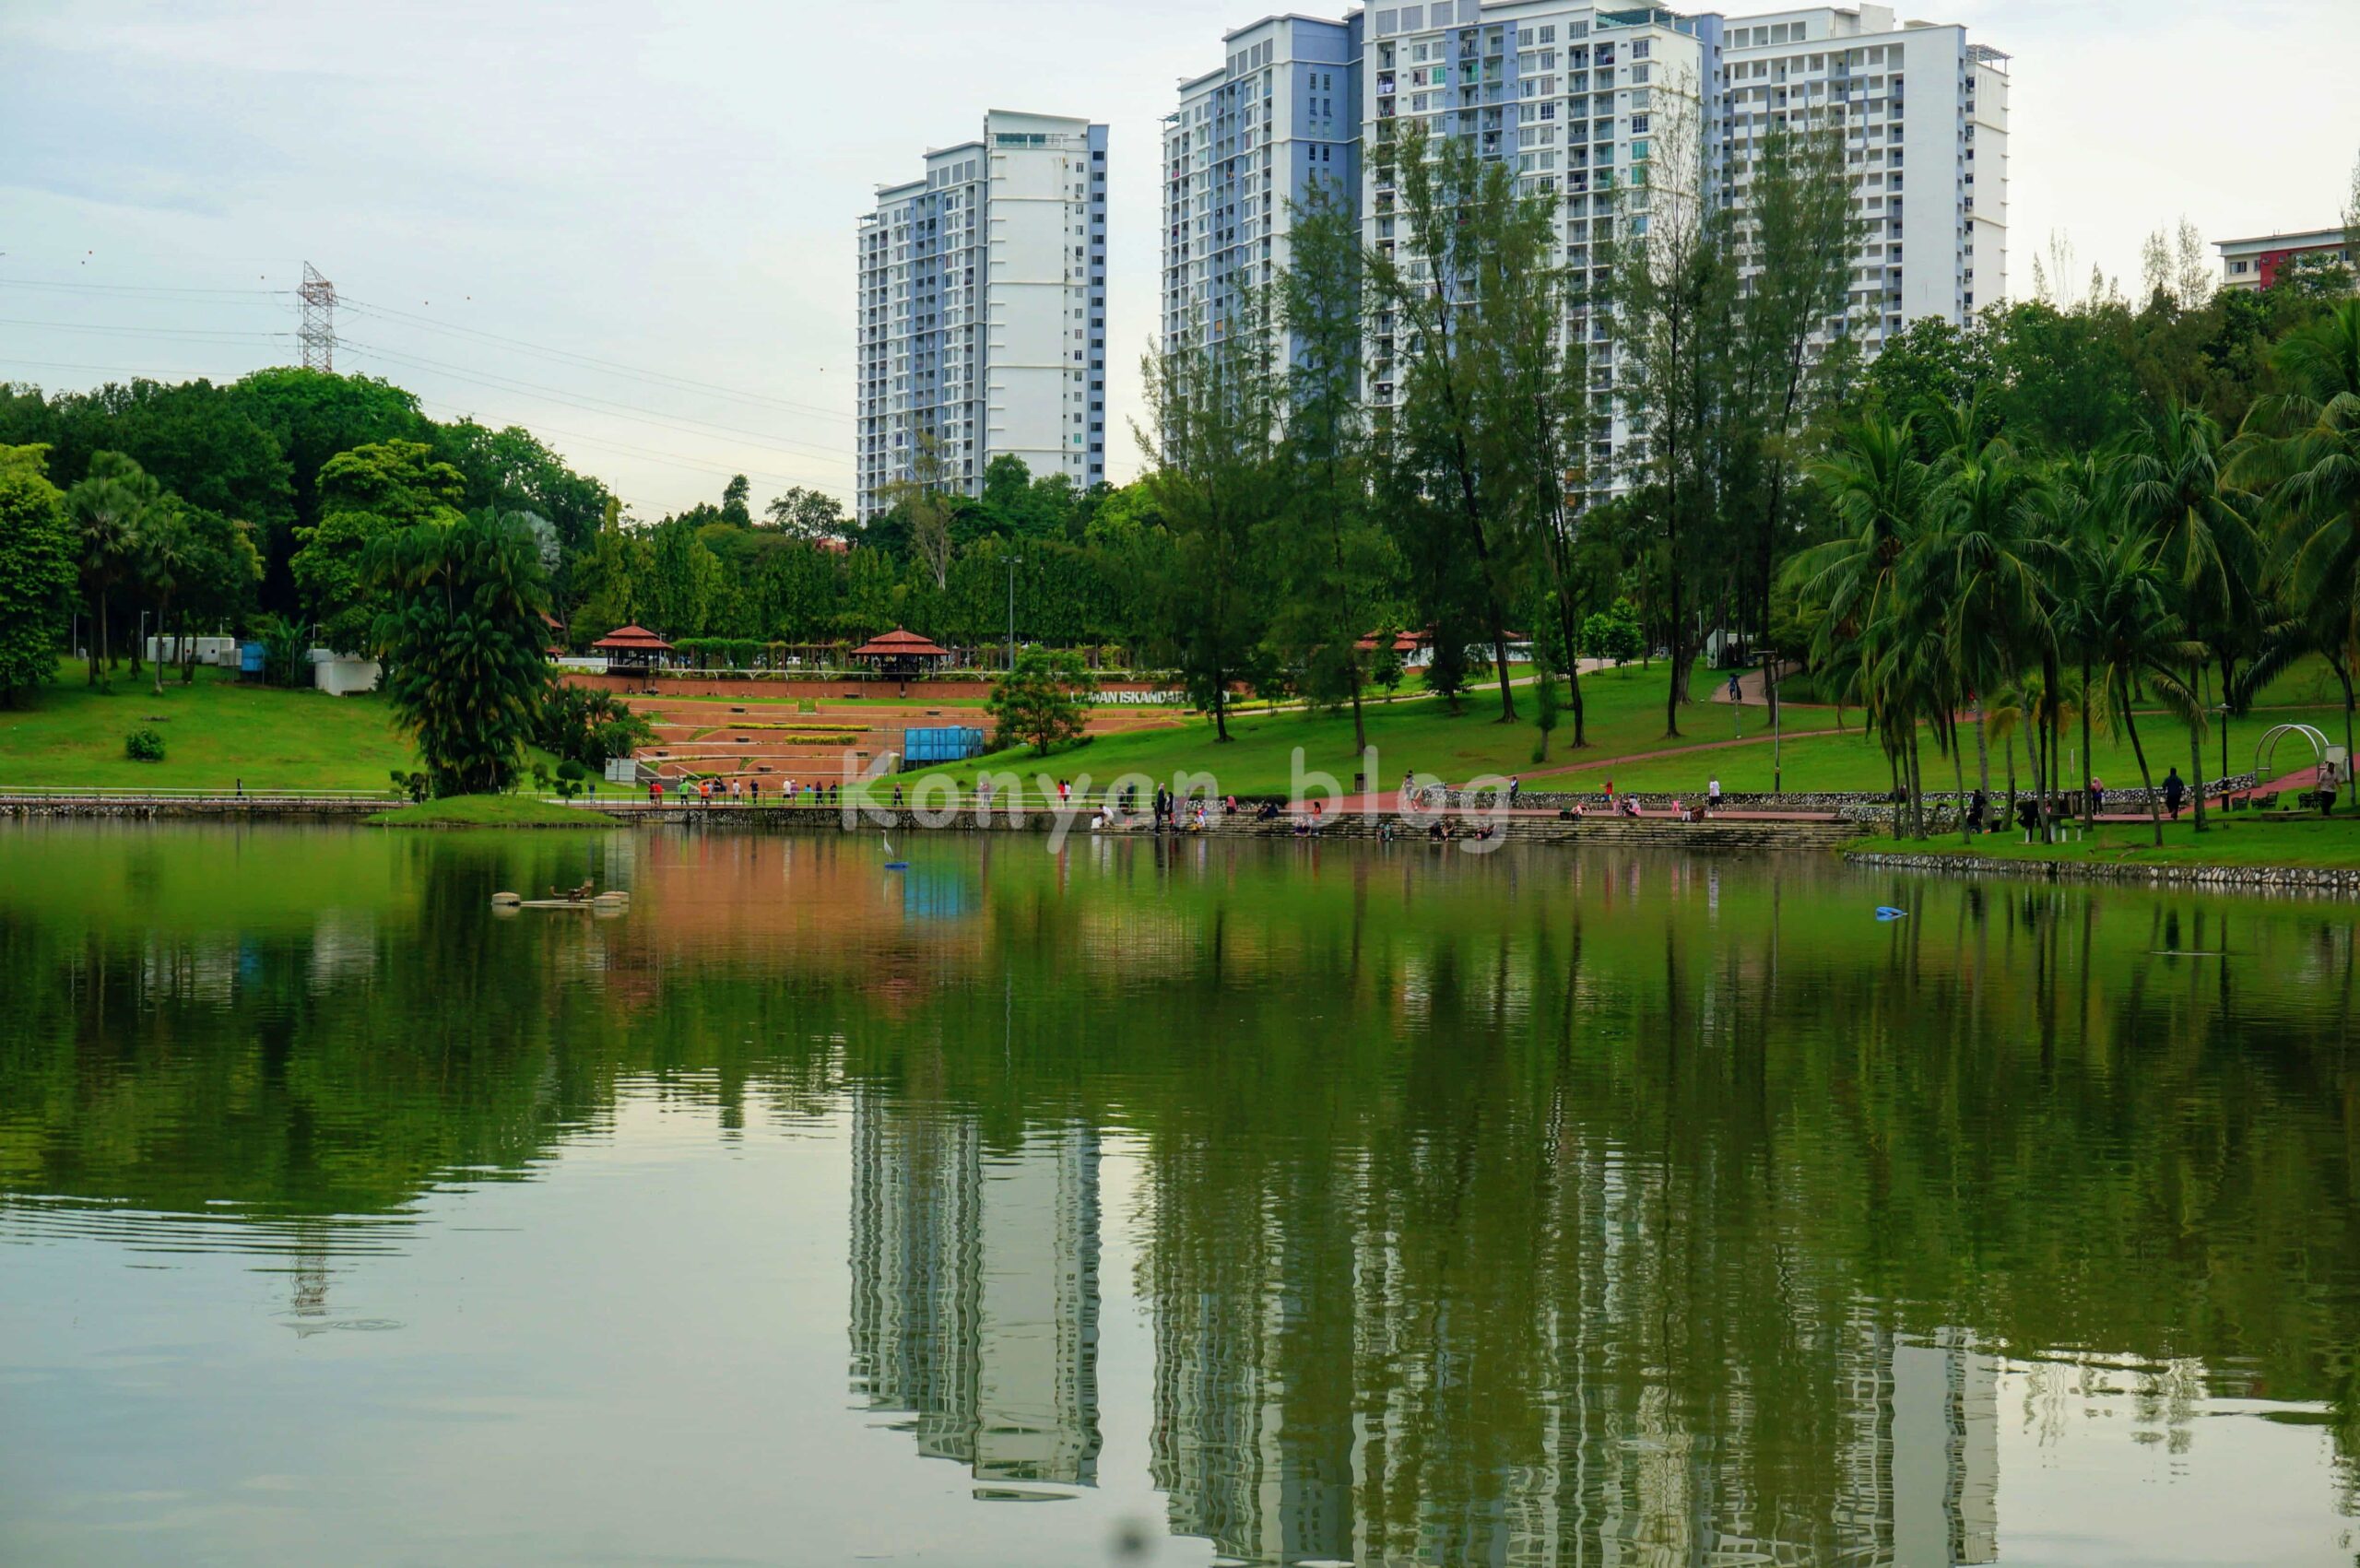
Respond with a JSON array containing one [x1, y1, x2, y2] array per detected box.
[[0, 0, 2360, 517]]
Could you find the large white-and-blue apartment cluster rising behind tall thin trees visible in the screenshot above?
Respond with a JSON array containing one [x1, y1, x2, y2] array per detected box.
[[1163, 0, 2009, 472]]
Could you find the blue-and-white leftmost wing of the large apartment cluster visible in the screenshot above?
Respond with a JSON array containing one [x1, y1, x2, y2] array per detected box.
[[1162, 12, 1362, 352]]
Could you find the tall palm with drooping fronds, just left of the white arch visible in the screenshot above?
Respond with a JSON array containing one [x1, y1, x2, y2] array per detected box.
[[2121, 401, 2260, 833]]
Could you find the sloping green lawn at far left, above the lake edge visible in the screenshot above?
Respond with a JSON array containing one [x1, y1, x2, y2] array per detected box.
[[0, 661, 418, 789]]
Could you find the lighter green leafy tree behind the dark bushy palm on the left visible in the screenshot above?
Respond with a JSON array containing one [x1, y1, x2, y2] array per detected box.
[[288, 442, 467, 654]]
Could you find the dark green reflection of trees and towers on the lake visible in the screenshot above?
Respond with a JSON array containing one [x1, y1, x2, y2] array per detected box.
[[0, 843, 2360, 1563]]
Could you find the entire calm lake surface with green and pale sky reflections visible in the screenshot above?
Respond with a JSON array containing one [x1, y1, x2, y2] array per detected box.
[[0, 827, 2360, 1568]]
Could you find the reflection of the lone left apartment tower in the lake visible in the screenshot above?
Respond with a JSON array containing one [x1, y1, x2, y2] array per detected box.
[[852, 1091, 1100, 1485]]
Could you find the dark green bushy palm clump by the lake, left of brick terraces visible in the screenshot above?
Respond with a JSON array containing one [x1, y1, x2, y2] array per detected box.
[[366, 508, 549, 796]]
